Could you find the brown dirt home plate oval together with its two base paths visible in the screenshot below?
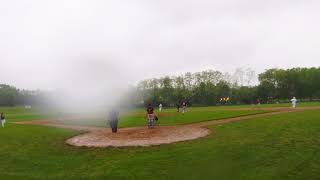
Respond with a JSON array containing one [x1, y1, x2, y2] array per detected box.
[[17, 107, 320, 147]]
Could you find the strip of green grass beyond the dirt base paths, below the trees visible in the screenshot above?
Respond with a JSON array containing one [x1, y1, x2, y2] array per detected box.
[[0, 102, 320, 124]]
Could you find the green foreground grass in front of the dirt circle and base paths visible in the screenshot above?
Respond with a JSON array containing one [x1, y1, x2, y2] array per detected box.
[[0, 106, 320, 180]]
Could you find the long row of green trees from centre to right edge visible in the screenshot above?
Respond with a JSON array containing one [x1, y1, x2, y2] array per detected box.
[[132, 68, 320, 106]]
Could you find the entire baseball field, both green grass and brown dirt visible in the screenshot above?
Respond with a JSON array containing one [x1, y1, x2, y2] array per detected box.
[[0, 103, 320, 180]]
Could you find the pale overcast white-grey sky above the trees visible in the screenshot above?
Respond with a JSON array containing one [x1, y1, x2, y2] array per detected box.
[[0, 0, 320, 89]]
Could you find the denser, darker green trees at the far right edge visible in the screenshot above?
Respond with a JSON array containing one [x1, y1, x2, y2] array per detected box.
[[256, 68, 320, 100]]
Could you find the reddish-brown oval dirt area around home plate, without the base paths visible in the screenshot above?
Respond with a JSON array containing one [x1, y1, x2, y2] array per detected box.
[[67, 126, 210, 147]]
